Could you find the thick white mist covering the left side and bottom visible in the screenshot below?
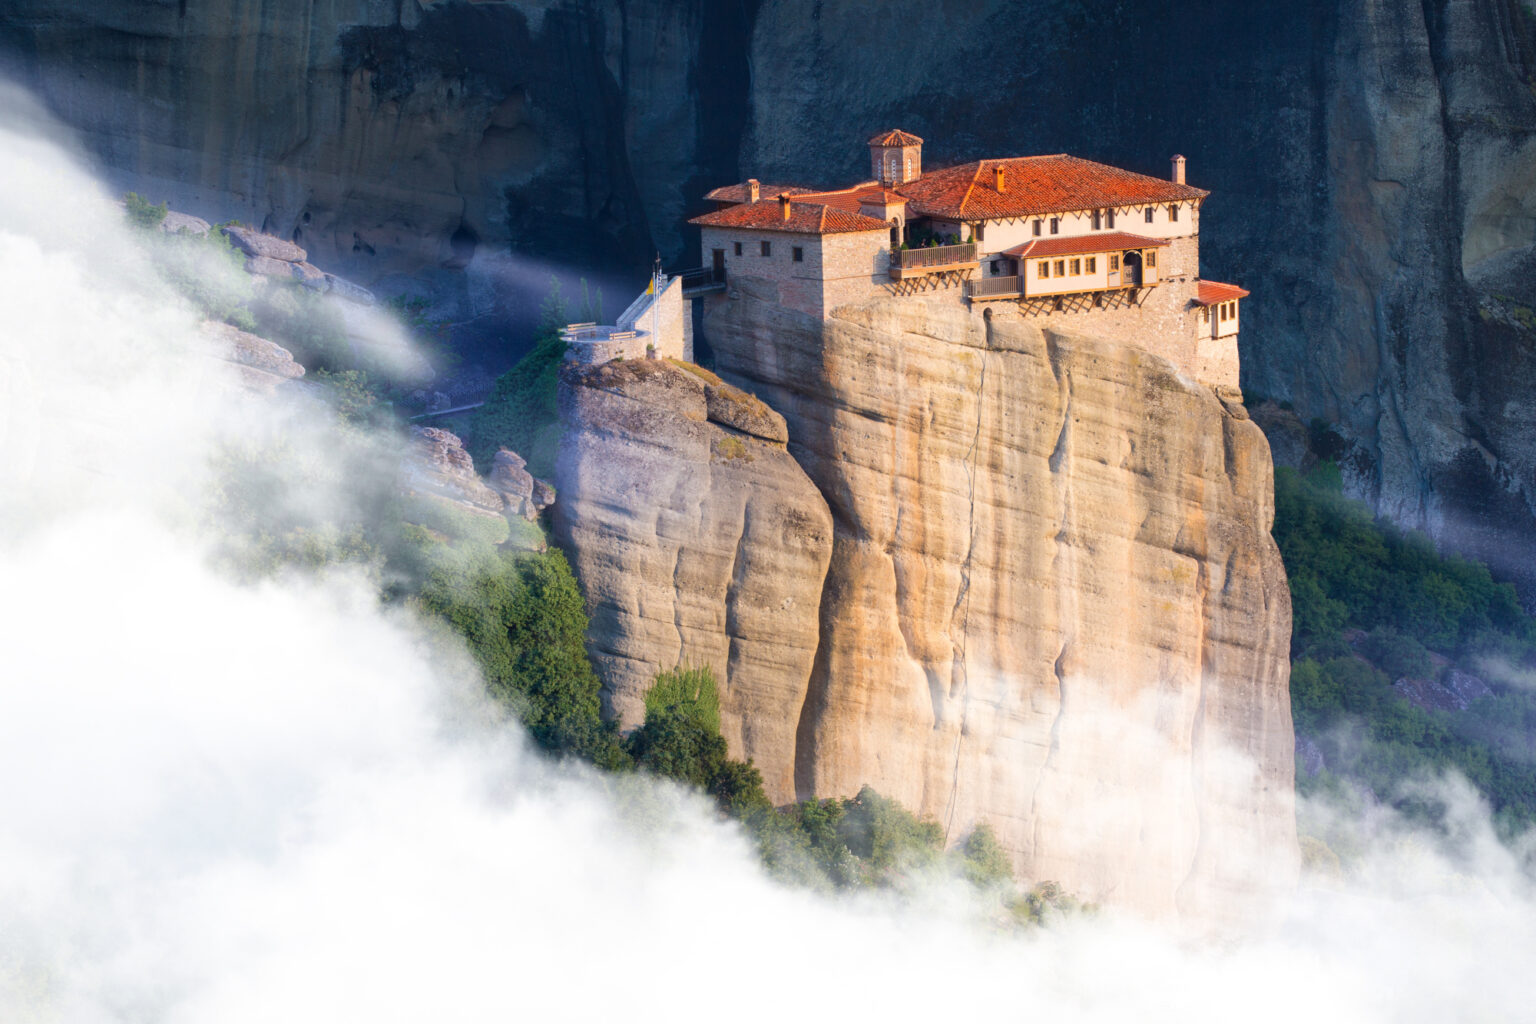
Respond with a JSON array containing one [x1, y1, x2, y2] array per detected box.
[[0, 85, 1536, 1024]]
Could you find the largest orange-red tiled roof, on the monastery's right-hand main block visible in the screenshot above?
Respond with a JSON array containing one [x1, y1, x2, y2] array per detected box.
[[897, 154, 1210, 221]]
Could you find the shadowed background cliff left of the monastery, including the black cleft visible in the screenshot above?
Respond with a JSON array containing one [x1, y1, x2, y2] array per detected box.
[[0, 0, 724, 323]]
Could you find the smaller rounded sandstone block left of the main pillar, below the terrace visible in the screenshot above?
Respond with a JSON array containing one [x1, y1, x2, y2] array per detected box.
[[554, 359, 833, 801]]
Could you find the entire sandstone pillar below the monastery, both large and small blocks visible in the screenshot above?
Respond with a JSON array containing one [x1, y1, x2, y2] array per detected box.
[[556, 286, 1296, 917]]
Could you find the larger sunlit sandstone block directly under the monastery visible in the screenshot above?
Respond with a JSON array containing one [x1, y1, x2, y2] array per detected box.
[[707, 286, 1295, 913]]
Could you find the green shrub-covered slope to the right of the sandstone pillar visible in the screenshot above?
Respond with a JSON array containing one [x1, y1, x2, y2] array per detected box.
[[1275, 463, 1536, 849]]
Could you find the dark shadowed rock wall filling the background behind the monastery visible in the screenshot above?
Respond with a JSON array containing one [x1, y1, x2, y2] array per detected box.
[[0, 0, 1536, 582]]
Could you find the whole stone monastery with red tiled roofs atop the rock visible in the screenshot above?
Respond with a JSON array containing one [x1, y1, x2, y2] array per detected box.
[[690, 130, 1247, 387]]
